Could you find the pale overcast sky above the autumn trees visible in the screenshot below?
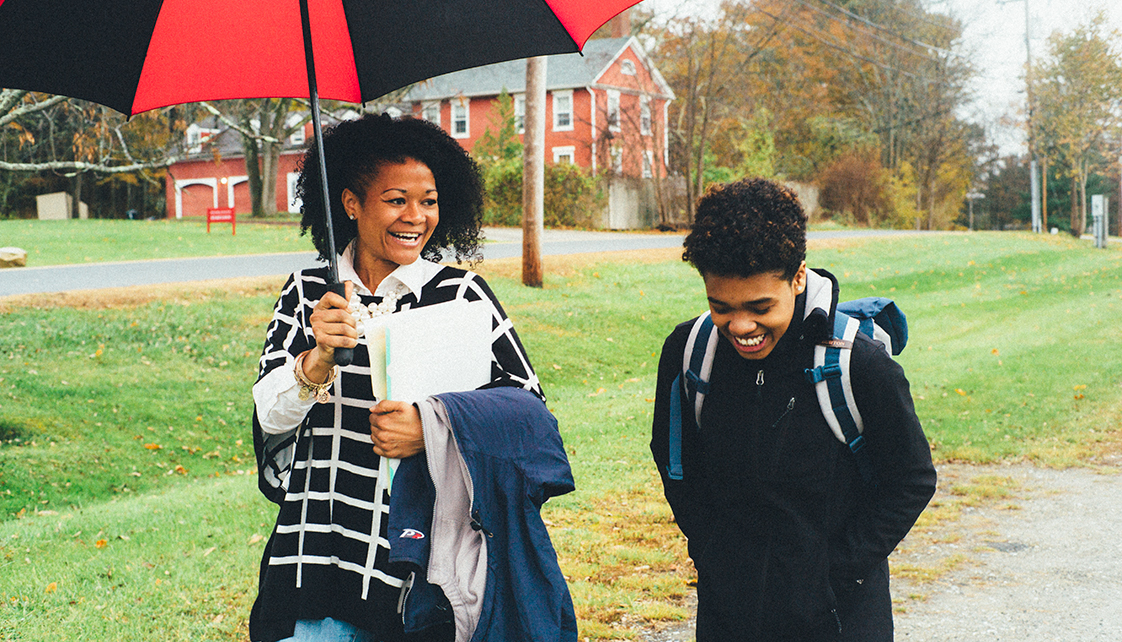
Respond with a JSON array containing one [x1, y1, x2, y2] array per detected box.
[[643, 0, 1122, 153]]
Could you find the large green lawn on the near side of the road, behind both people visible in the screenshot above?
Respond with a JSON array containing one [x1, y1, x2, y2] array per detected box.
[[0, 233, 1122, 640]]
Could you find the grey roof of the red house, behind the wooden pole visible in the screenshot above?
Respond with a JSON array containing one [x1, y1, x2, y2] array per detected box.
[[403, 38, 672, 102]]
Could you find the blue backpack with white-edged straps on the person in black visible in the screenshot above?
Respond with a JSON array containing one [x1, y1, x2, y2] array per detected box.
[[666, 270, 908, 486]]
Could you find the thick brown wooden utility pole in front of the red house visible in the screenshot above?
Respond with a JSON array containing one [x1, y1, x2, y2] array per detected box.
[[522, 56, 546, 287]]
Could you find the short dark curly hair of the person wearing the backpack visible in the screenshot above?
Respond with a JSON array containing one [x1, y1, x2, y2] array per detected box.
[[682, 178, 807, 281]]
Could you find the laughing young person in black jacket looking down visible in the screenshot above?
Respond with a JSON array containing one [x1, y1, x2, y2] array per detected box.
[[651, 178, 936, 642]]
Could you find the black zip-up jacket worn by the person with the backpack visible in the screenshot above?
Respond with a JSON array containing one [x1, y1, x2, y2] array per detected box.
[[651, 272, 936, 642]]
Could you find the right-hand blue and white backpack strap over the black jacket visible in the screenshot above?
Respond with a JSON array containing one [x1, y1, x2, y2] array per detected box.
[[806, 312, 876, 486]]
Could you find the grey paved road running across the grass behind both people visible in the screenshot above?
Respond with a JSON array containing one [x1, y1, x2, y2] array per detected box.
[[0, 228, 899, 296]]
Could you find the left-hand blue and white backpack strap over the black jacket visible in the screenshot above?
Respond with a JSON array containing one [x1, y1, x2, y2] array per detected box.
[[666, 312, 718, 480]]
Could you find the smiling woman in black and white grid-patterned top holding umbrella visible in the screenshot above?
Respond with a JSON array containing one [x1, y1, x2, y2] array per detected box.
[[250, 116, 556, 642]]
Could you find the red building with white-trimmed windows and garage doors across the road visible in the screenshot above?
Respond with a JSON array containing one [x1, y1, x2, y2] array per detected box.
[[166, 38, 674, 227]]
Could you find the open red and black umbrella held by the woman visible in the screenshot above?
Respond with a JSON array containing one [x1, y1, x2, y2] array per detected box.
[[0, 0, 638, 361]]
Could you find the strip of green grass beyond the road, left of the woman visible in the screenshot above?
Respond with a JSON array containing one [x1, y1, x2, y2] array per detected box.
[[0, 218, 314, 267]]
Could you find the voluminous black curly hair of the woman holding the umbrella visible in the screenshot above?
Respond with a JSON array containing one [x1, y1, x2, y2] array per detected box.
[[296, 113, 484, 263]]
